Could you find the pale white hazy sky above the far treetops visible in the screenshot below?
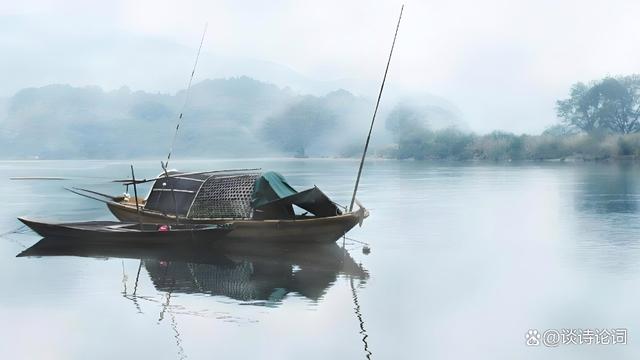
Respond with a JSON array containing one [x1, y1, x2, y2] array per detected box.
[[0, 0, 640, 133]]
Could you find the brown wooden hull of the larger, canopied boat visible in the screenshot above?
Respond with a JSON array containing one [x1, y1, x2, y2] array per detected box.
[[107, 202, 368, 243]]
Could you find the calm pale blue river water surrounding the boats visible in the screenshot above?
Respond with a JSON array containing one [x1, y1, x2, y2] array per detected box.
[[0, 160, 640, 359]]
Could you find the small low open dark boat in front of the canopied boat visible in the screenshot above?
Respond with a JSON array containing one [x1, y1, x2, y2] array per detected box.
[[18, 217, 231, 244]]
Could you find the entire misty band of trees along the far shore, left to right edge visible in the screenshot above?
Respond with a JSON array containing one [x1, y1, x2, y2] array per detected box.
[[5, 75, 640, 161]]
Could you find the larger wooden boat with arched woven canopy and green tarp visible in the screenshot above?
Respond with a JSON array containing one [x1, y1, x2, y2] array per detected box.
[[71, 170, 369, 243]]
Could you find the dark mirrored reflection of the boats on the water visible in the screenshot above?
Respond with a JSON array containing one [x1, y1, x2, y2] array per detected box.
[[18, 238, 369, 306]]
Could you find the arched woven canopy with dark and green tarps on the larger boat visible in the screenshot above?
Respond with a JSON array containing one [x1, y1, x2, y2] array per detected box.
[[140, 170, 341, 220]]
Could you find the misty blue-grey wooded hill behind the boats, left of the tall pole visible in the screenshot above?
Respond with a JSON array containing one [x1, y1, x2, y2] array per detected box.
[[0, 77, 462, 159]]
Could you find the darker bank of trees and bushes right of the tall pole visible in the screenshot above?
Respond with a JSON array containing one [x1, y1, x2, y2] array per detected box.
[[381, 74, 640, 161]]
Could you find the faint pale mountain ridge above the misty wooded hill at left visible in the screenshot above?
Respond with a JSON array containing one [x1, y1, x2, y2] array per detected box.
[[0, 15, 378, 96]]
